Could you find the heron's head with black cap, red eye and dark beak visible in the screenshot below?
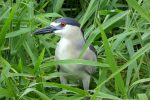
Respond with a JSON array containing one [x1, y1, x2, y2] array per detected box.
[[33, 17, 82, 38]]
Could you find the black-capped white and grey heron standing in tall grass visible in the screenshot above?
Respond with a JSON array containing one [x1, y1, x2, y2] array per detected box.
[[33, 17, 97, 90]]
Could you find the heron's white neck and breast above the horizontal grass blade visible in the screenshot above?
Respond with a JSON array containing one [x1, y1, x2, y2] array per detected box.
[[55, 30, 85, 60]]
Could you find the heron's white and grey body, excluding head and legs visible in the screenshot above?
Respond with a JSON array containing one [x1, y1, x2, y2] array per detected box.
[[55, 38, 96, 74]]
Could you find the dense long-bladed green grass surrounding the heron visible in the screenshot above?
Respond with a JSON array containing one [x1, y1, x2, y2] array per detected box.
[[0, 0, 150, 100]]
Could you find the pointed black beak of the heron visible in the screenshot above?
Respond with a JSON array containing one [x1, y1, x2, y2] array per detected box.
[[33, 26, 60, 35]]
